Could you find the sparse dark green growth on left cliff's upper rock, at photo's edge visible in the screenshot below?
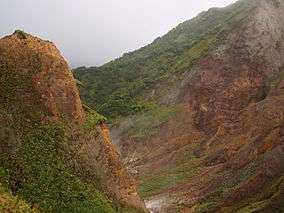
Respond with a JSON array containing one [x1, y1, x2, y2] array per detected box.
[[0, 58, 44, 129]]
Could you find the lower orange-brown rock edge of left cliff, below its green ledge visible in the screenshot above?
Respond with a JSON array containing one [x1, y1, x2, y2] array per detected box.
[[71, 124, 146, 212]]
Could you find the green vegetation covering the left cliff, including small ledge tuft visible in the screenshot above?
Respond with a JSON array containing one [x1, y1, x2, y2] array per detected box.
[[0, 32, 144, 213]]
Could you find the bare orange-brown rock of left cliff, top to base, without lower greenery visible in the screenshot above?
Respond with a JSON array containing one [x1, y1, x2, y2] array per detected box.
[[0, 31, 145, 212]]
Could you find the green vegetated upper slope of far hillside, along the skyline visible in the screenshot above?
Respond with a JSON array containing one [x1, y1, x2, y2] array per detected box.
[[74, 1, 253, 120]]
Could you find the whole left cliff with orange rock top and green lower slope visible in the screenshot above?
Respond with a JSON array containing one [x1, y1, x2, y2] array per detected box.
[[0, 31, 144, 213]]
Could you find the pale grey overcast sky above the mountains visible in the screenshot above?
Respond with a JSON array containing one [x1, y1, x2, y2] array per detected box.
[[0, 0, 235, 67]]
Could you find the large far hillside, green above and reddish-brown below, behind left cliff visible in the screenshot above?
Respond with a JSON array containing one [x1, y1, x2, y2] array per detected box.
[[74, 0, 284, 212]]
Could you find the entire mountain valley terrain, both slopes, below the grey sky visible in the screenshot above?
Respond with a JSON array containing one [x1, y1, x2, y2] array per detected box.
[[0, 0, 284, 213]]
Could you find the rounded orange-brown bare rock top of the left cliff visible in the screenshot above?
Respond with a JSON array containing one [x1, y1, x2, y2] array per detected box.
[[0, 31, 84, 122]]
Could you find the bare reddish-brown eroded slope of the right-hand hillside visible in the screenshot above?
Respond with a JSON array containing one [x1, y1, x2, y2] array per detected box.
[[116, 0, 284, 212]]
